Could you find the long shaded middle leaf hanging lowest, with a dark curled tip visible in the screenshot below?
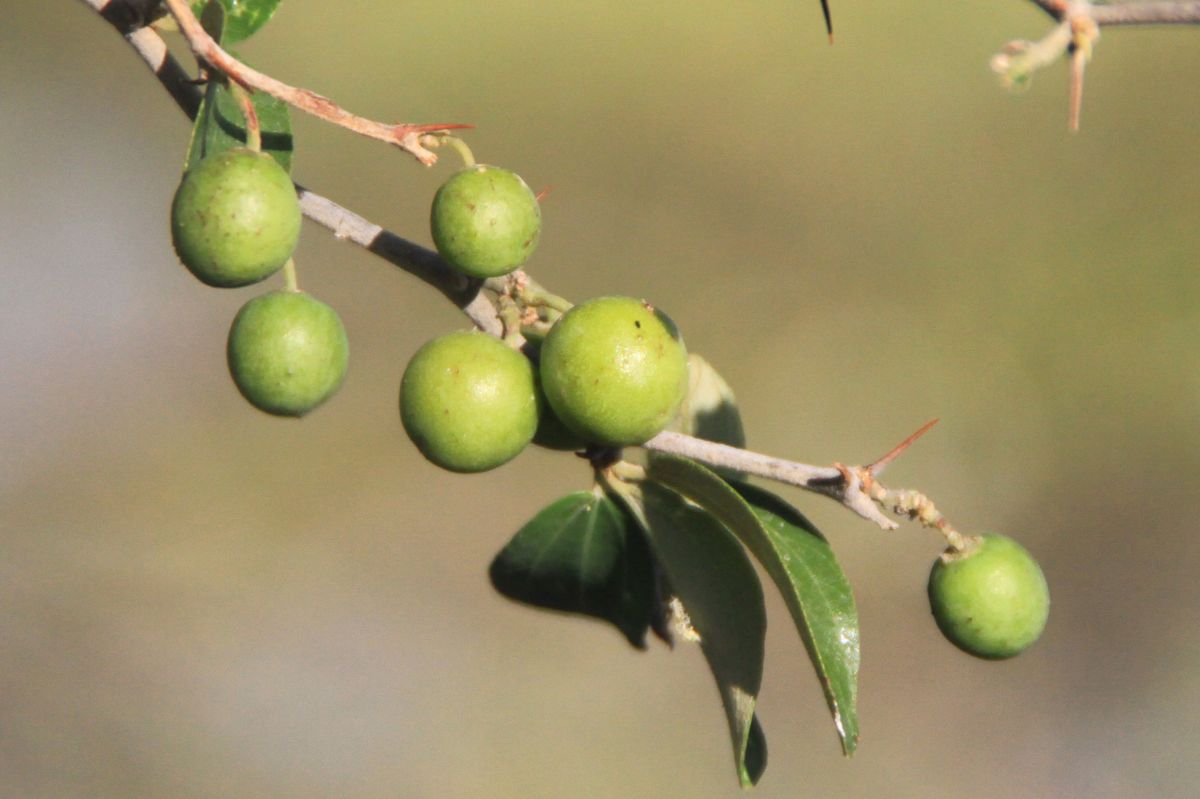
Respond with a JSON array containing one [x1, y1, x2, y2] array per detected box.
[[613, 482, 767, 787]]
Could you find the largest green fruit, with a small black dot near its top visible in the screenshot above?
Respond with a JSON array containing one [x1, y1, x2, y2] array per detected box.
[[540, 296, 688, 446]]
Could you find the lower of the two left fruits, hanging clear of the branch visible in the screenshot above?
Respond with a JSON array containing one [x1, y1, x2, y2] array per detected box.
[[226, 290, 350, 416]]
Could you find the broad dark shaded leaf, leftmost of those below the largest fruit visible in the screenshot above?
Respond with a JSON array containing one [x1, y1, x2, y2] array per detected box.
[[488, 491, 655, 649]]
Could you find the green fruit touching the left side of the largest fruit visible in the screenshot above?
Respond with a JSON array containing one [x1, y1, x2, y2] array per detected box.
[[400, 331, 540, 473]]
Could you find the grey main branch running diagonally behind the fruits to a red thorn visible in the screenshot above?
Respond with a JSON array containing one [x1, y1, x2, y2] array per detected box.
[[82, 0, 953, 535]]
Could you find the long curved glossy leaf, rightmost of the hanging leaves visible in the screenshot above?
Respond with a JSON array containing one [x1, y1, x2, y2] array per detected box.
[[648, 456, 859, 755]]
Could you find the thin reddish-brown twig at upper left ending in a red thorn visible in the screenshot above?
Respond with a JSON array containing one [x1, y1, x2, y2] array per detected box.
[[152, 0, 470, 166]]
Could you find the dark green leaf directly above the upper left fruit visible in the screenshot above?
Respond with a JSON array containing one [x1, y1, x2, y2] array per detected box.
[[185, 67, 292, 172]]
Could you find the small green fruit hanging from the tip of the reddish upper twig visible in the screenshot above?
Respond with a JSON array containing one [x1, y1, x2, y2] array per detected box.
[[430, 164, 541, 277]]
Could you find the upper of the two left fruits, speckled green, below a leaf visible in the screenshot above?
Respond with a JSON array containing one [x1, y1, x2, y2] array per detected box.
[[170, 148, 300, 288]]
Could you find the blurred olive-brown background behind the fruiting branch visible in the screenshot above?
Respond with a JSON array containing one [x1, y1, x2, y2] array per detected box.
[[0, 0, 1200, 799]]
